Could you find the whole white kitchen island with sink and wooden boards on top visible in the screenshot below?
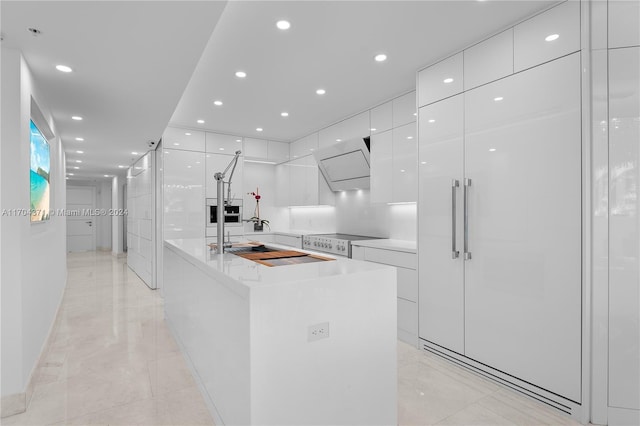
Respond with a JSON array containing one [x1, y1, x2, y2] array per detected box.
[[163, 239, 397, 425]]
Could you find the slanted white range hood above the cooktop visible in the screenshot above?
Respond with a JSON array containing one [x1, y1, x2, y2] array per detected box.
[[313, 137, 371, 191]]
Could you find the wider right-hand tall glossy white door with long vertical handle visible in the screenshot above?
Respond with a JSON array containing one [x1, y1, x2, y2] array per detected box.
[[462, 53, 582, 403]]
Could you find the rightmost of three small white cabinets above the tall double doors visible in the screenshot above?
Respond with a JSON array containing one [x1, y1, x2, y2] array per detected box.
[[514, 0, 580, 72]]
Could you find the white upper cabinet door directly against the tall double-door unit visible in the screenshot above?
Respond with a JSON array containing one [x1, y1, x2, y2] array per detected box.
[[391, 123, 418, 202]]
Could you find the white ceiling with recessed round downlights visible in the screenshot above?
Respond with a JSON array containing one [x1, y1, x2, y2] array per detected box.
[[0, 0, 557, 177]]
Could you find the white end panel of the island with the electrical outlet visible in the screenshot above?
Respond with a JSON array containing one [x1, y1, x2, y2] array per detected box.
[[251, 266, 397, 425]]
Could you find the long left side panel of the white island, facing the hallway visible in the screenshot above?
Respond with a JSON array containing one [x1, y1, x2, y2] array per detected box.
[[164, 247, 251, 425]]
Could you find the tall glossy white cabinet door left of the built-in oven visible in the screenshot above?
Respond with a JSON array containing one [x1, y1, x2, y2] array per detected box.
[[163, 149, 205, 239]]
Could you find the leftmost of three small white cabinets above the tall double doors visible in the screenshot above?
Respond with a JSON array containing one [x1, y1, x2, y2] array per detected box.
[[418, 52, 463, 106]]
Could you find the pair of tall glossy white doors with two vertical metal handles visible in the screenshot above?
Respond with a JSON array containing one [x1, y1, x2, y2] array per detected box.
[[418, 54, 582, 403]]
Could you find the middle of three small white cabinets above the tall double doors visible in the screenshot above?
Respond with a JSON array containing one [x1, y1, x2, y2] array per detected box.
[[464, 28, 513, 90]]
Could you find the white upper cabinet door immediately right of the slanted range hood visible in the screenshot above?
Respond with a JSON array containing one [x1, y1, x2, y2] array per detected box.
[[370, 130, 393, 203]]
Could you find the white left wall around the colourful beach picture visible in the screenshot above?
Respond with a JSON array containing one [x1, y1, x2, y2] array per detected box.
[[0, 47, 66, 415]]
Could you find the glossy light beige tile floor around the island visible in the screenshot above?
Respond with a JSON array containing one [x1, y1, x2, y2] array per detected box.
[[1, 252, 577, 426]]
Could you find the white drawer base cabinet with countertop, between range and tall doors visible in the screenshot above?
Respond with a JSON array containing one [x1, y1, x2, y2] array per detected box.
[[351, 245, 418, 346]]
